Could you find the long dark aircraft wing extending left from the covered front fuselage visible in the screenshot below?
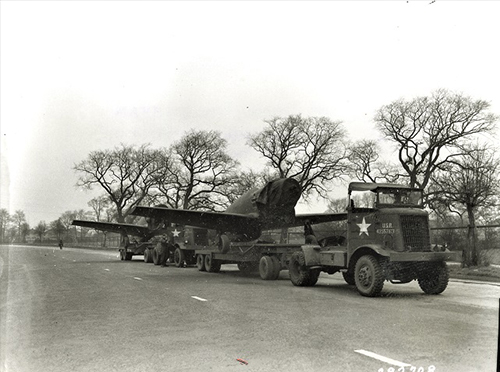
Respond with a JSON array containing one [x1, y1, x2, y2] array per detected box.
[[131, 206, 259, 233]]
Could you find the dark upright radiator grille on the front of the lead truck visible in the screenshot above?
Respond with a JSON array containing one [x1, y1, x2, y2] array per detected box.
[[400, 215, 431, 252]]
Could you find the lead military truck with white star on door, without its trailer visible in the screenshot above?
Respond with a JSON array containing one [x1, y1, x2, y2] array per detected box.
[[288, 182, 461, 297]]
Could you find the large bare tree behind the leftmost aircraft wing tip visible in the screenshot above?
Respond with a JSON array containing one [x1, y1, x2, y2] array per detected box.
[[74, 144, 159, 222]]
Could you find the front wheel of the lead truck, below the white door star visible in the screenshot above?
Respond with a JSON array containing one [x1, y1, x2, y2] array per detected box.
[[354, 255, 385, 297]]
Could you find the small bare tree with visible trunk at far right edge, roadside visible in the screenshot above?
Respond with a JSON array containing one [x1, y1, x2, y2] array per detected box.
[[429, 146, 500, 266]]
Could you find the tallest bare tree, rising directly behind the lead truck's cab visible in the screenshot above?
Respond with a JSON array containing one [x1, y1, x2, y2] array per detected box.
[[375, 89, 497, 188]]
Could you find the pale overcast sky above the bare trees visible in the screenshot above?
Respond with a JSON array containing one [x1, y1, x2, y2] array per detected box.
[[0, 0, 500, 226]]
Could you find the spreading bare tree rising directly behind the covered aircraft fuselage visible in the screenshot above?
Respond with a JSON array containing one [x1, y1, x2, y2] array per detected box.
[[248, 115, 348, 199]]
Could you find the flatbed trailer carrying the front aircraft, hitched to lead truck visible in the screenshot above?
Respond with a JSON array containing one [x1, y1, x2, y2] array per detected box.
[[194, 243, 302, 280]]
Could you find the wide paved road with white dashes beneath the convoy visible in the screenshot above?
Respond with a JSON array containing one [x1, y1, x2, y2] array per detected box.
[[0, 246, 500, 372]]
